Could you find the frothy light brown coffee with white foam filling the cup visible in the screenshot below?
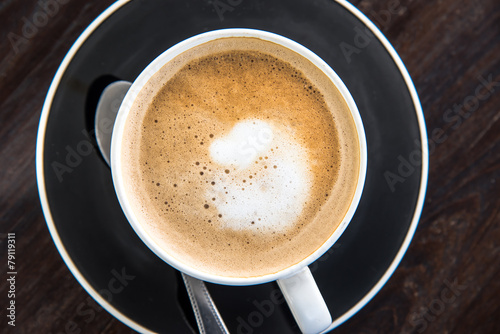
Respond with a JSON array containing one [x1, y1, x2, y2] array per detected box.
[[122, 37, 360, 277]]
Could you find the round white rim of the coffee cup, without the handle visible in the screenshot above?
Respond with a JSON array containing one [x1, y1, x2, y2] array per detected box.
[[111, 28, 367, 285]]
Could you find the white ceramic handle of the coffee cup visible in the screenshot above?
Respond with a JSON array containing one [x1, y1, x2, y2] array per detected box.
[[277, 267, 332, 334]]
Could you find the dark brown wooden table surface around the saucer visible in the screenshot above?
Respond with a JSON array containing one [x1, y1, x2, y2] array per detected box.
[[0, 0, 500, 334]]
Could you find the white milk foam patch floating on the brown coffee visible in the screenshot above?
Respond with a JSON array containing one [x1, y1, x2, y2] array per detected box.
[[206, 120, 312, 233]]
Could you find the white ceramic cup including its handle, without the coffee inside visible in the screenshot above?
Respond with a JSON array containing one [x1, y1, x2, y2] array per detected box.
[[111, 29, 367, 333]]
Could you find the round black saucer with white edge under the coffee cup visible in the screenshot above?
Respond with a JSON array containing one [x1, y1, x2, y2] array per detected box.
[[37, 0, 428, 333]]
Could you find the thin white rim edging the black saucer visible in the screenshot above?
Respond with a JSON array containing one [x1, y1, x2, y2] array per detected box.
[[36, 0, 429, 333]]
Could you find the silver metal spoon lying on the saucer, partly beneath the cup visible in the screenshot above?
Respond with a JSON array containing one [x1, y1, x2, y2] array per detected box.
[[95, 81, 229, 334]]
